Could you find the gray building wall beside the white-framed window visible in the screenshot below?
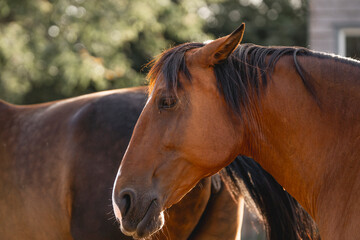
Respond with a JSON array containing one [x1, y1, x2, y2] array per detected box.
[[308, 0, 360, 53]]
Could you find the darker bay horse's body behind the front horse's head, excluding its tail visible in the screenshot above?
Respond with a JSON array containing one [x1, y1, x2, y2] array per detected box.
[[0, 88, 243, 240]]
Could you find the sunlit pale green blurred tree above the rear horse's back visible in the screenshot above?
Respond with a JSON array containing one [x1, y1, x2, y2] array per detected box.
[[0, 0, 208, 103]]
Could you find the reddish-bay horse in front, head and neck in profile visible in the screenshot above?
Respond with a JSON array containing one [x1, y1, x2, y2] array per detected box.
[[113, 24, 360, 240]]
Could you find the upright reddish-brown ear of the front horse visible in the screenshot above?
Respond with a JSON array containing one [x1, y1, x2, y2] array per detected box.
[[194, 23, 245, 66]]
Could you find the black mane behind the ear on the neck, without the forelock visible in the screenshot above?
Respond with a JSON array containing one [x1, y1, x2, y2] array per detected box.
[[214, 44, 316, 117]]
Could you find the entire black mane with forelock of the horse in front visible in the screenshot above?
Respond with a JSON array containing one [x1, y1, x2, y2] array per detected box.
[[147, 43, 360, 117]]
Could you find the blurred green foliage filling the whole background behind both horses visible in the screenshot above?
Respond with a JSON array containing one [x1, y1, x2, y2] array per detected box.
[[0, 0, 307, 104]]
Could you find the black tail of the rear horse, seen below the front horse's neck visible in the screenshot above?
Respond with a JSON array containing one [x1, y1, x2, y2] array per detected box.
[[220, 156, 320, 240]]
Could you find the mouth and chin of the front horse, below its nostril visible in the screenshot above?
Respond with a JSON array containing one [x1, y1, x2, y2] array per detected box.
[[121, 199, 164, 239]]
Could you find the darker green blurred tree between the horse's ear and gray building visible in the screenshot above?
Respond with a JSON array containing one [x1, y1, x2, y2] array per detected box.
[[199, 0, 308, 46]]
